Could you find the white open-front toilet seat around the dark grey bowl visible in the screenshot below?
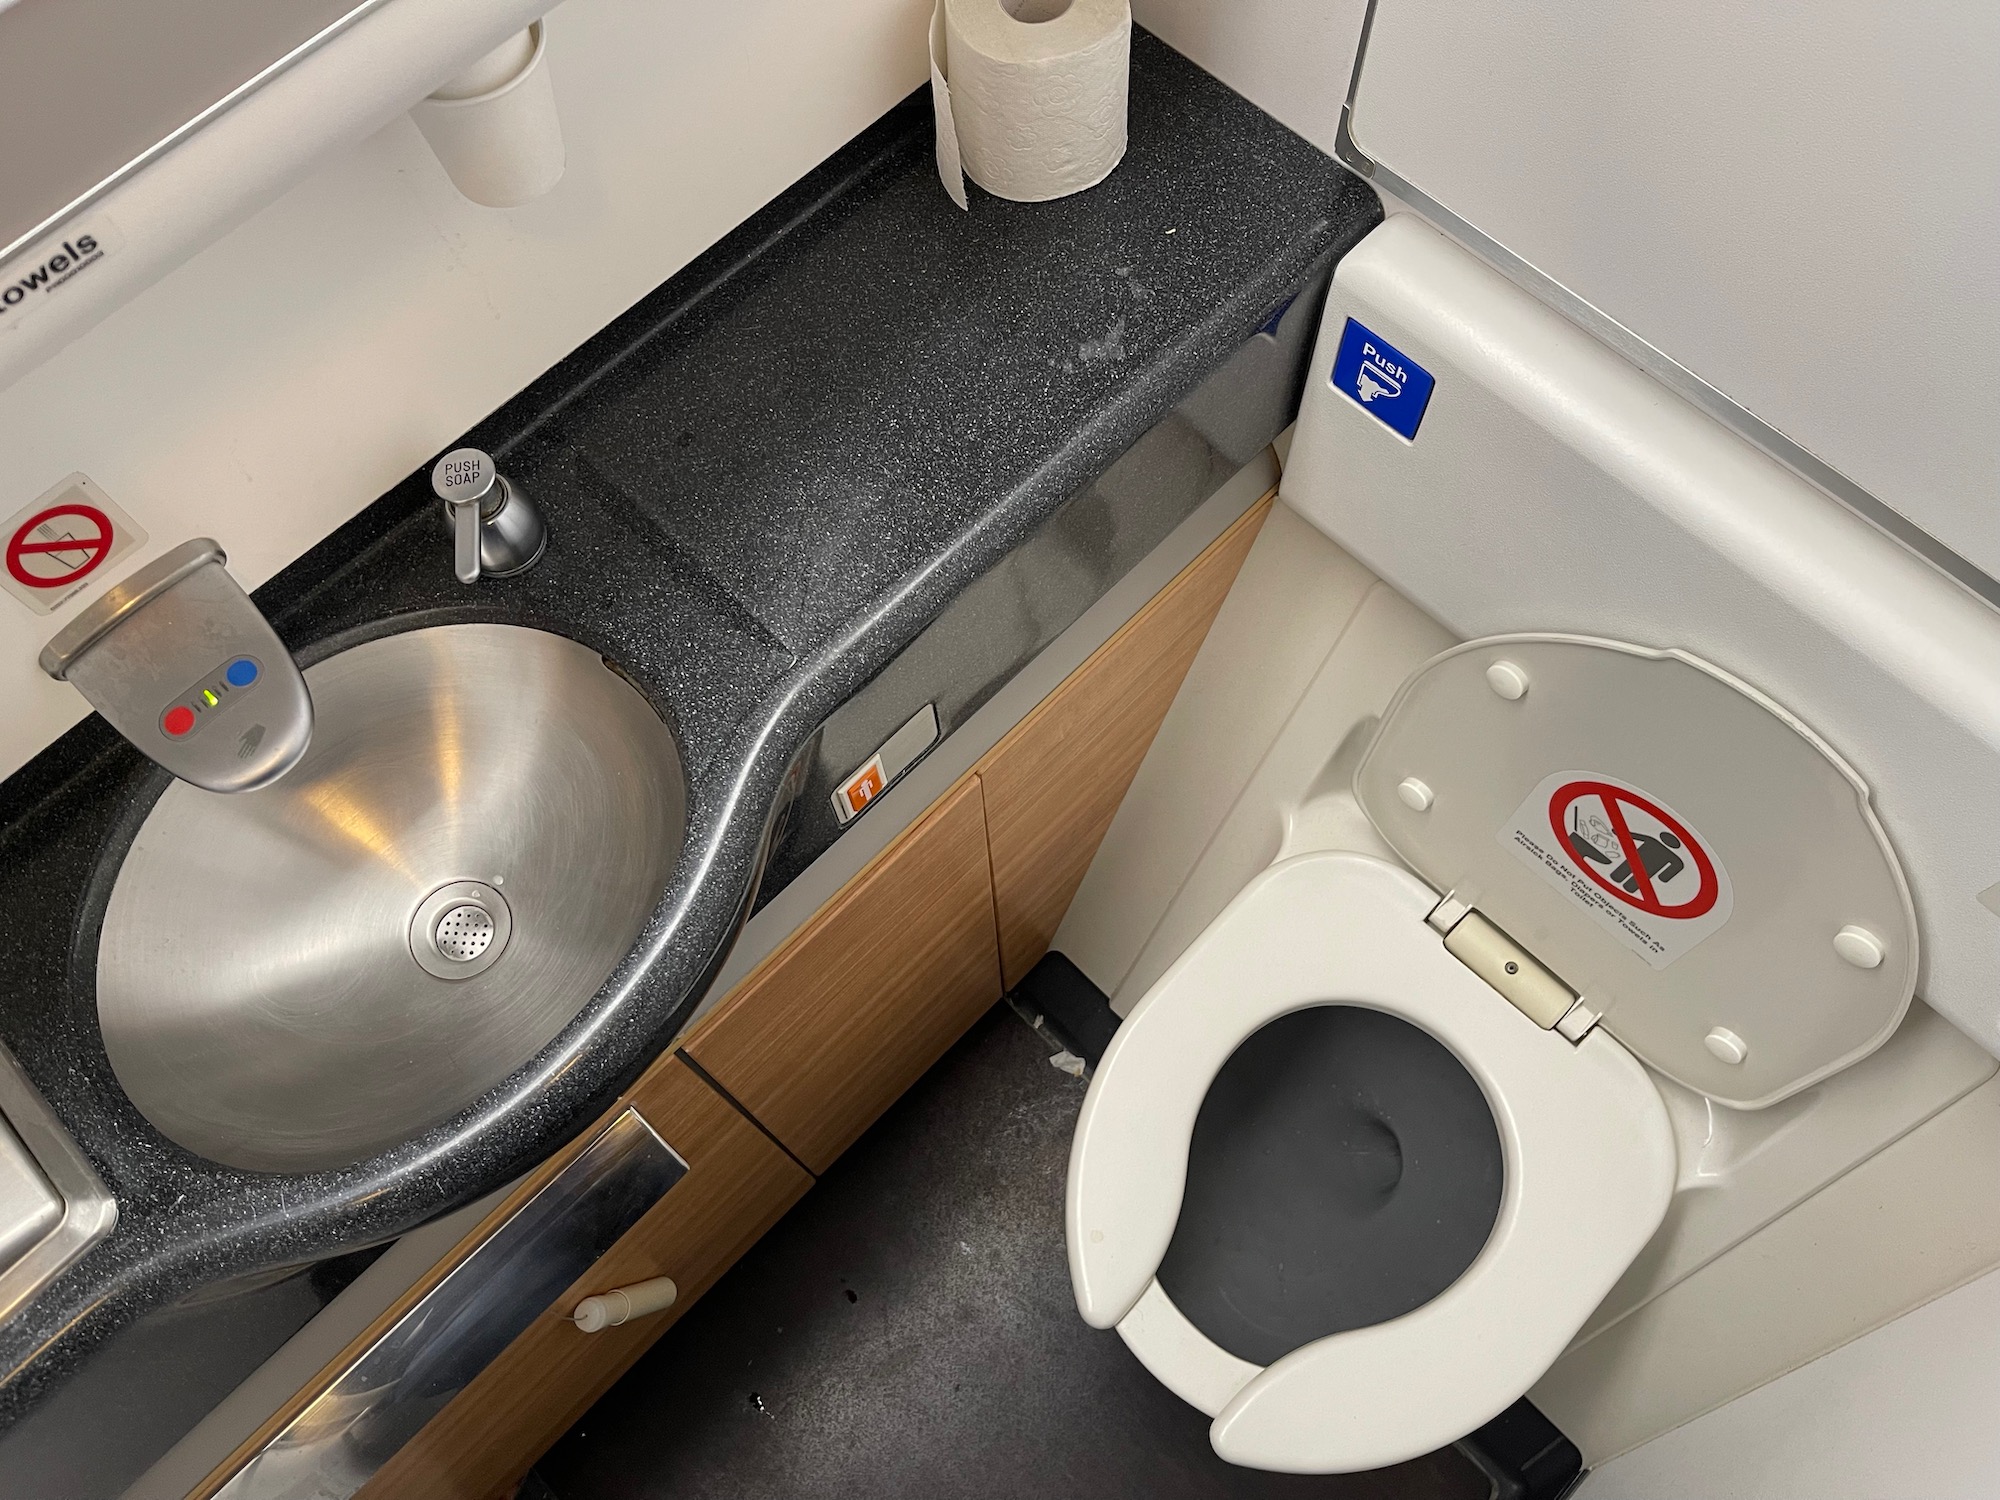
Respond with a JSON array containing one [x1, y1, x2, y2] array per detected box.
[[1066, 854, 1676, 1472]]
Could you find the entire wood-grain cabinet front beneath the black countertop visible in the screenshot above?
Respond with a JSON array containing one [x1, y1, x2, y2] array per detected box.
[[203, 494, 1270, 1500]]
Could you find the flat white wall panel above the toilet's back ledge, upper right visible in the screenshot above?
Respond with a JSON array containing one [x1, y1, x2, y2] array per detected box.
[[1352, 0, 2000, 588]]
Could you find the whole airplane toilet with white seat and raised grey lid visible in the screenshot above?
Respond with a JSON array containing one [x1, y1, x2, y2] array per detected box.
[[1066, 634, 1918, 1472]]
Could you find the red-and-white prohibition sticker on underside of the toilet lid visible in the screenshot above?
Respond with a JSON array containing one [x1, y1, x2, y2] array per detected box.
[[1500, 772, 1734, 968]]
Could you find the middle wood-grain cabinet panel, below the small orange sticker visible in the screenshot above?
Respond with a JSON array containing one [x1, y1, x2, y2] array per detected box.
[[686, 778, 1000, 1172]]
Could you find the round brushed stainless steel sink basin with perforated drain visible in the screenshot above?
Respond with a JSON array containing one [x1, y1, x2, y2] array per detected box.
[[98, 624, 686, 1172]]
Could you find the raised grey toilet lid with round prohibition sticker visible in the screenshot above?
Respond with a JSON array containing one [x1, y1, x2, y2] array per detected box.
[[1354, 634, 1918, 1108]]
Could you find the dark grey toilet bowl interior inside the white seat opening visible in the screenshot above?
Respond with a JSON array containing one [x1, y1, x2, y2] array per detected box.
[[1158, 1004, 1504, 1364]]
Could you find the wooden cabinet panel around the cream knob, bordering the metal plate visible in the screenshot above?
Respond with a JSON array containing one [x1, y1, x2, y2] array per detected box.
[[362, 1056, 812, 1500]]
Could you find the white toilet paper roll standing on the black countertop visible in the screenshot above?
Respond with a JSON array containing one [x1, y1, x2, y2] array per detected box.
[[930, 0, 1132, 208]]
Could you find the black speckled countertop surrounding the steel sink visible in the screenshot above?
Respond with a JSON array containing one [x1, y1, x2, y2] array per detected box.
[[0, 34, 1380, 1426]]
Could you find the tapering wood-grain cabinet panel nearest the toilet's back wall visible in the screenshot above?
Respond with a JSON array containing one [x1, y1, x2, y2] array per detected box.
[[976, 496, 1270, 986]]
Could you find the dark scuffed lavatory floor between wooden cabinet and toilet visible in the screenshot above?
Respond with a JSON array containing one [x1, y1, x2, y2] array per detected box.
[[524, 1004, 1488, 1500]]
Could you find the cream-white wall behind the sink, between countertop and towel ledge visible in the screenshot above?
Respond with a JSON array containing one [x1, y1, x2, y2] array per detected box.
[[0, 0, 930, 776]]
